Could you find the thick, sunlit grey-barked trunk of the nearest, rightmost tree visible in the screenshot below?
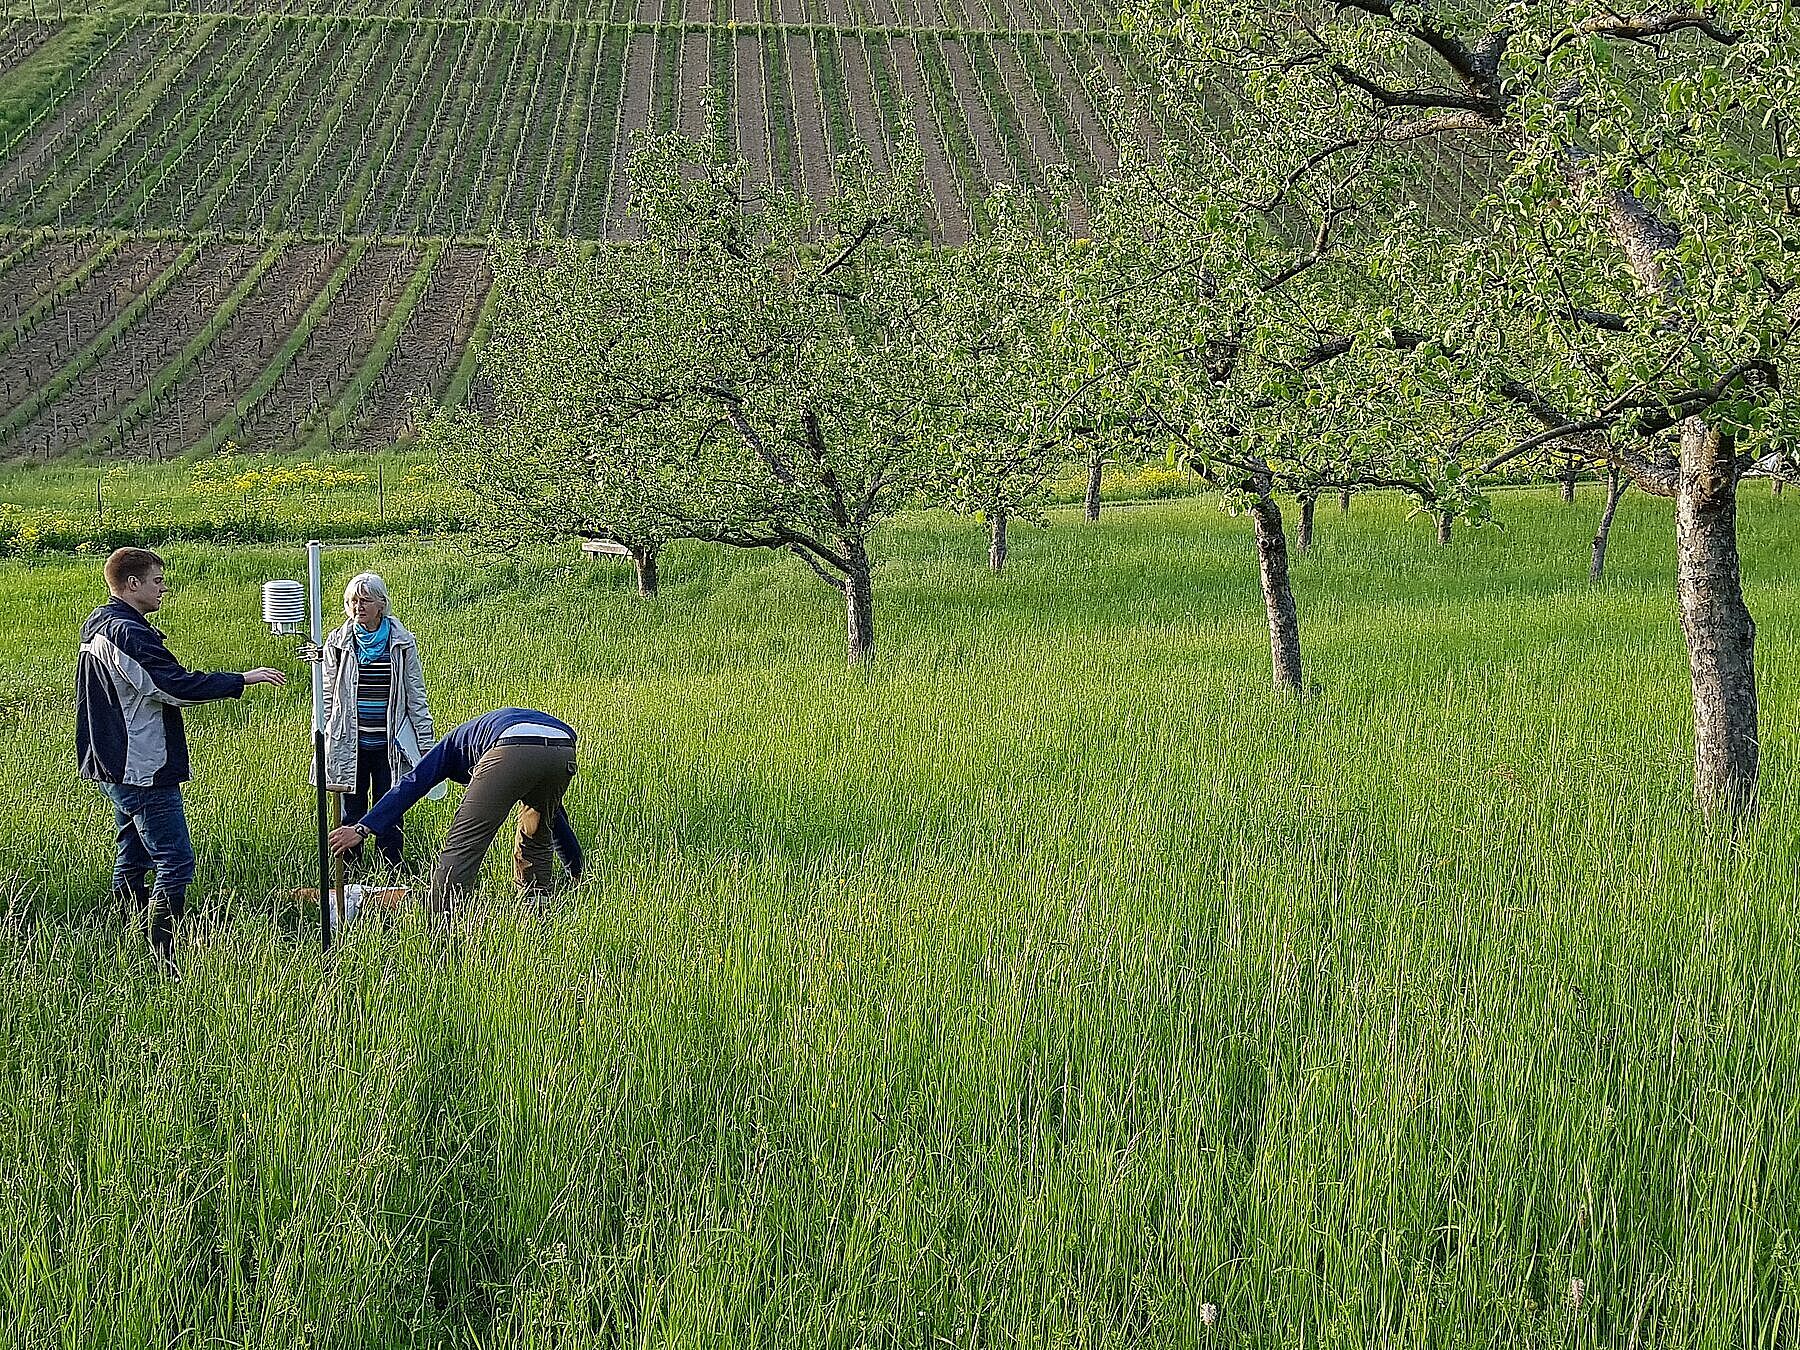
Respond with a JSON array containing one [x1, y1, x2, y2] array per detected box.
[[1676, 418, 1759, 817]]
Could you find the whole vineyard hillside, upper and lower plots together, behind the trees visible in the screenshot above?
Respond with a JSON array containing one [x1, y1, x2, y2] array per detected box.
[[0, 0, 1159, 459]]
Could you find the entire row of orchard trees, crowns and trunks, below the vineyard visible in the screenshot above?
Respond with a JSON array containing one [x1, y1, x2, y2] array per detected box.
[[428, 0, 1800, 815]]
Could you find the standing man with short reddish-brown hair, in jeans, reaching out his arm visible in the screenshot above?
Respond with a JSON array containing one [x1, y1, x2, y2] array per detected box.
[[76, 549, 288, 974]]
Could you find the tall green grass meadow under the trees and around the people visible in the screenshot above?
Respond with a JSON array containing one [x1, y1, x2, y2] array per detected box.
[[0, 490, 1800, 1350]]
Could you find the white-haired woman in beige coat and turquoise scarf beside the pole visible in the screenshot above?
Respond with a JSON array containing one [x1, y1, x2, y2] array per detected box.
[[324, 572, 434, 866]]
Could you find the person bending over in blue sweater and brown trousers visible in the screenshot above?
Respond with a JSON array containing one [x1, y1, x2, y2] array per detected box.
[[331, 707, 581, 914]]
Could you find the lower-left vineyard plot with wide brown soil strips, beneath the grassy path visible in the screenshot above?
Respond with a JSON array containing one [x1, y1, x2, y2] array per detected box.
[[0, 230, 491, 459]]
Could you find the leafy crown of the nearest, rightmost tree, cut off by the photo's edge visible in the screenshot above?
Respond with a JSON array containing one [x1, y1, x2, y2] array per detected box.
[[1138, 0, 1800, 486]]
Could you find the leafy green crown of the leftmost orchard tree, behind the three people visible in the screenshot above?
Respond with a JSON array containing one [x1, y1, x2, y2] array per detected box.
[[430, 137, 941, 648]]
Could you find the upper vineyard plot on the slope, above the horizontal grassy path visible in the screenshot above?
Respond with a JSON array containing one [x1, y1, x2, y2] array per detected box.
[[0, 13, 1157, 241]]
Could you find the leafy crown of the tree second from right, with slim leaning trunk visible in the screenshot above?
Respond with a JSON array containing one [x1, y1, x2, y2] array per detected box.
[[1062, 144, 1494, 518]]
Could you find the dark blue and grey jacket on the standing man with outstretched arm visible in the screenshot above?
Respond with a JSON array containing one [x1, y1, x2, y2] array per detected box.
[[76, 599, 243, 787]]
